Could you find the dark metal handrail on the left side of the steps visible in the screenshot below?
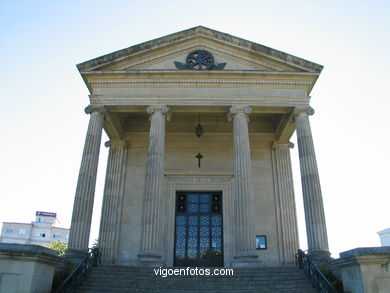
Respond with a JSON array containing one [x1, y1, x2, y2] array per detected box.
[[54, 247, 102, 293]]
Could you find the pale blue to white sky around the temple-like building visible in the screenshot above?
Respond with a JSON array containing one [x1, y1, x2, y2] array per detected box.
[[0, 0, 390, 258]]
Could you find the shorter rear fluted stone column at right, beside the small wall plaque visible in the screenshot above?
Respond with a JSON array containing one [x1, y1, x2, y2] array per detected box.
[[272, 142, 299, 264]]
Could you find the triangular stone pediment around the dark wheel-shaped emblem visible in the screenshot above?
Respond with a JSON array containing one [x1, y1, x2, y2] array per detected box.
[[77, 26, 322, 73]]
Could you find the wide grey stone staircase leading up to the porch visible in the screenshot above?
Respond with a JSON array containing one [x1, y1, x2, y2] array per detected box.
[[76, 265, 318, 293]]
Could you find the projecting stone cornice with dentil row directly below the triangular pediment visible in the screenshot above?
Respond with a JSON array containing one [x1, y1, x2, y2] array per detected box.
[[82, 70, 318, 95]]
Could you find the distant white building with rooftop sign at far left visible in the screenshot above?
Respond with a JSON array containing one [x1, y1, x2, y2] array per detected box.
[[0, 211, 69, 247]]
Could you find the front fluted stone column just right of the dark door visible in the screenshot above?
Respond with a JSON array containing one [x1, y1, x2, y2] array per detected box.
[[230, 106, 257, 264]]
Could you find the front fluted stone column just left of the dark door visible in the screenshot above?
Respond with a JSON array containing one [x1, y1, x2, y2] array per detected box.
[[138, 106, 169, 264]]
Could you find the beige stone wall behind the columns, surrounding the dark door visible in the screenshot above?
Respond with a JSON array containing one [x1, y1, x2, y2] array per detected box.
[[116, 131, 292, 266]]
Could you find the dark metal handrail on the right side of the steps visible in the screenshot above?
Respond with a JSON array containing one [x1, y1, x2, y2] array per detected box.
[[295, 249, 337, 293]]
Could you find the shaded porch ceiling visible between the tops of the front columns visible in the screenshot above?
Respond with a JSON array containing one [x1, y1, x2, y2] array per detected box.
[[104, 104, 295, 143]]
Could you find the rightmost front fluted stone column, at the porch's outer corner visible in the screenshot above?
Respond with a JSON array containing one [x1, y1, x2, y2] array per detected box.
[[293, 107, 329, 257]]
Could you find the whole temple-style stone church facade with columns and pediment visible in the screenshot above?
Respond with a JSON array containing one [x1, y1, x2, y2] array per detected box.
[[69, 26, 329, 267]]
